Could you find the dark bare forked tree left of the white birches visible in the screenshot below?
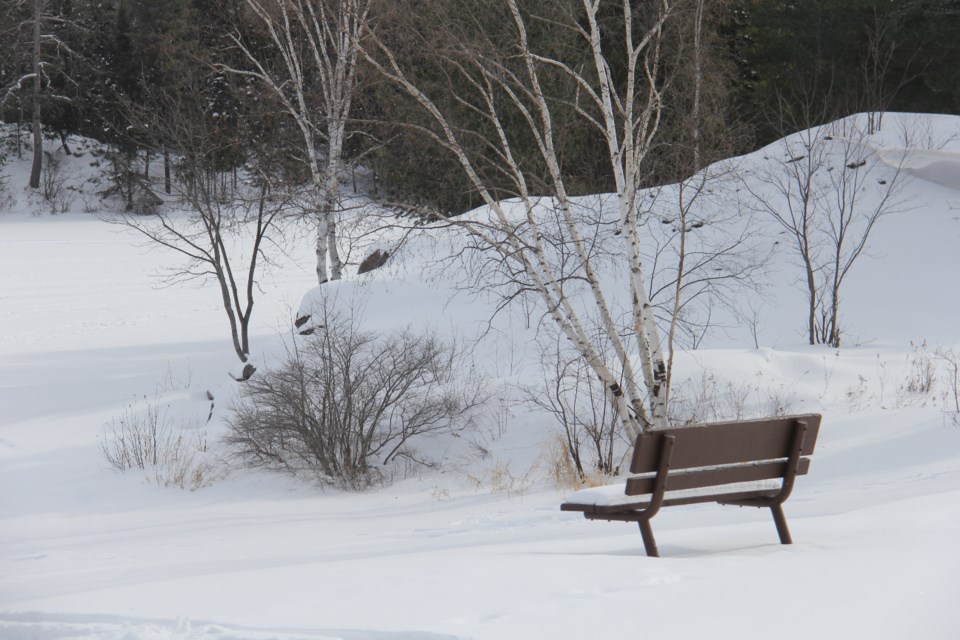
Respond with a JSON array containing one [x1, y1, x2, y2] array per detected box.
[[119, 94, 293, 364]]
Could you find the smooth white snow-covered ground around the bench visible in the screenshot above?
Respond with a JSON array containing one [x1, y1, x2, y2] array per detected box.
[[0, 114, 960, 640]]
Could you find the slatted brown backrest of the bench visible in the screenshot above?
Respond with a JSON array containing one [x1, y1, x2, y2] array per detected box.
[[626, 413, 820, 495]]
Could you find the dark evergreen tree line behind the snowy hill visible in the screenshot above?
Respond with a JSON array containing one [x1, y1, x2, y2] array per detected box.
[[0, 0, 960, 212]]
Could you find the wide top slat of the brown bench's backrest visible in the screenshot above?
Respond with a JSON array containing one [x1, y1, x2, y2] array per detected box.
[[630, 414, 820, 473]]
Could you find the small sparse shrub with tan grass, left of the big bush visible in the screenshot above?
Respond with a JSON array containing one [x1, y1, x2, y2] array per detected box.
[[100, 394, 225, 491]]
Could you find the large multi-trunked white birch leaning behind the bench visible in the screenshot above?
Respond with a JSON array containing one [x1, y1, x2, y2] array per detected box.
[[366, 0, 671, 435]]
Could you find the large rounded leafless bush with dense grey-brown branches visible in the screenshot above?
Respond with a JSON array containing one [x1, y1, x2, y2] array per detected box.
[[227, 308, 483, 489]]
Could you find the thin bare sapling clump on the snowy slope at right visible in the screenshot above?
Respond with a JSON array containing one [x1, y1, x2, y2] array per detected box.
[[742, 116, 905, 347]]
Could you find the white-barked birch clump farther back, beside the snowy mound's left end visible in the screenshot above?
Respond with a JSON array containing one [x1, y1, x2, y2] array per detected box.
[[221, 0, 369, 284]]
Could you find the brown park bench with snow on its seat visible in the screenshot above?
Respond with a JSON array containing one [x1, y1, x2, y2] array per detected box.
[[560, 413, 820, 557]]
